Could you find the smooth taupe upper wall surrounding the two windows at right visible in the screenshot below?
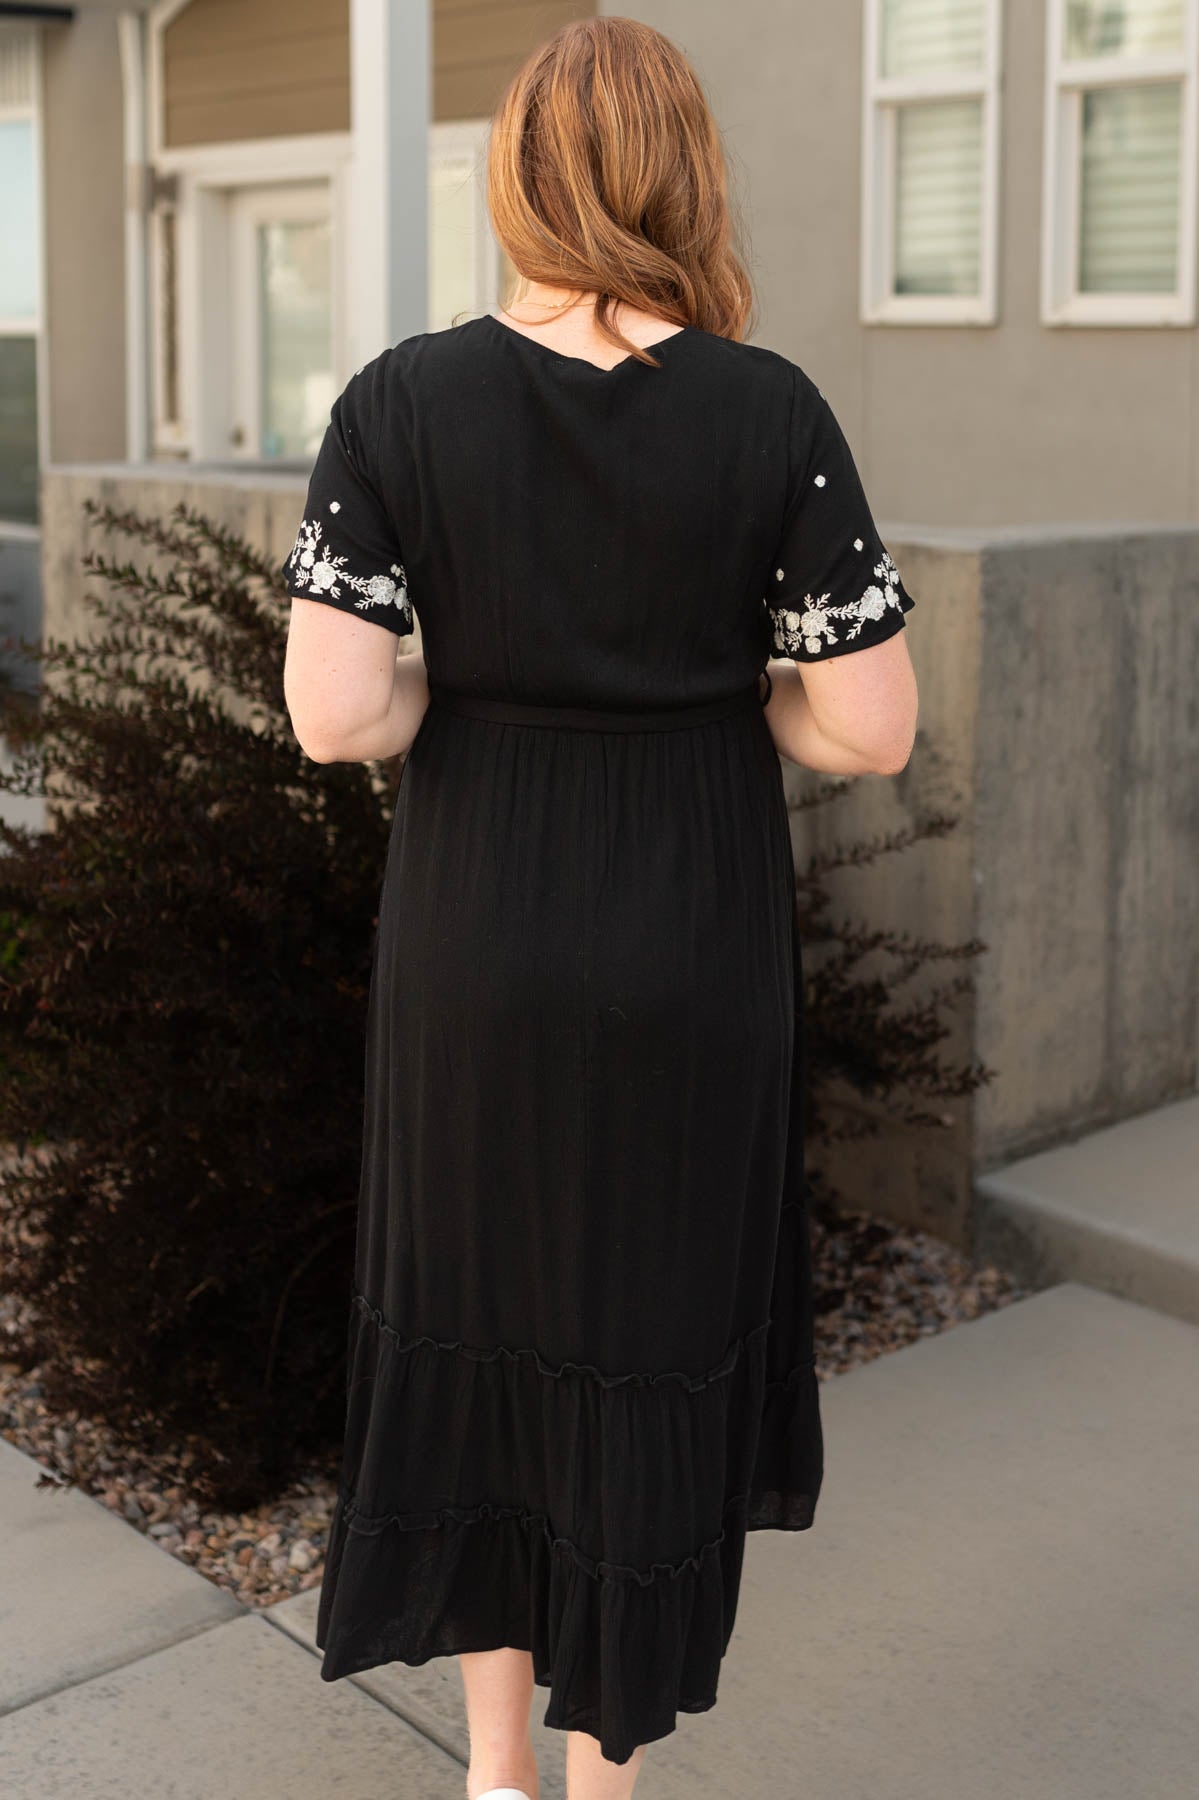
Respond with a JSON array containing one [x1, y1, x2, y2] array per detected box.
[[615, 0, 1199, 526]]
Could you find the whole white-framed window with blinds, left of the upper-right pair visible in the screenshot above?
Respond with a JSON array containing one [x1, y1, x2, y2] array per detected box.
[[862, 0, 1001, 324]]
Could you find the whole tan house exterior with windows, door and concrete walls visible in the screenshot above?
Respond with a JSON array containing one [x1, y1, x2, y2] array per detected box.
[[0, 0, 1199, 1238]]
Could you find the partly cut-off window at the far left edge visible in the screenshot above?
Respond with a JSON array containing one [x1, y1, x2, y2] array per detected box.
[[0, 25, 41, 526]]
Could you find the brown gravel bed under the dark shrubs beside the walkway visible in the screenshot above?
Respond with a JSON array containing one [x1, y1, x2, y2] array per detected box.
[[0, 1213, 1028, 1607]]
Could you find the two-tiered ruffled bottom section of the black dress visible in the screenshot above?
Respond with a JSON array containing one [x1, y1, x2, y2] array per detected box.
[[309, 1281, 821, 1762]]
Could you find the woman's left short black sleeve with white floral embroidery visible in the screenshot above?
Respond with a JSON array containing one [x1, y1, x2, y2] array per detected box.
[[283, 351, 412, 637]]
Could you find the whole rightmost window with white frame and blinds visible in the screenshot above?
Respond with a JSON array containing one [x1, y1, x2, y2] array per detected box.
[[1041, 0, 1199, 326]]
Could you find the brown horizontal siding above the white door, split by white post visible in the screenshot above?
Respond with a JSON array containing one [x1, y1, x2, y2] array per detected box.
[[162, 0, 596, 146]]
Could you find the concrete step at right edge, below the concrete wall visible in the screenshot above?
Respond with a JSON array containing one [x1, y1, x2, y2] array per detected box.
[[972, 1096, 1199, 1323]]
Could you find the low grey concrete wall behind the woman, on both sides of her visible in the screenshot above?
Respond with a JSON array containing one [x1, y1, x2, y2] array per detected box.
[[43, 464, 1199, 1242]]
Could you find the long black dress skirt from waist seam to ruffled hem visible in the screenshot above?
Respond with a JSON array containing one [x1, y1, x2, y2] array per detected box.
[[309, 682, 823, 1762]]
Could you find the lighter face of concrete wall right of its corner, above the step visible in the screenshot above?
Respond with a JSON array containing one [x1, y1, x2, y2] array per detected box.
[[974, 529, 1199, 1165]]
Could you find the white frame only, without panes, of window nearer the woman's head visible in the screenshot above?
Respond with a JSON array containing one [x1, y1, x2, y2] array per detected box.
[[859, 0, 1003, 326]]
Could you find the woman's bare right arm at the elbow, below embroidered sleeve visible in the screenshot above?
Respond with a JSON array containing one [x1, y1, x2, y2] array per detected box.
[[765, 632, 918, 776]]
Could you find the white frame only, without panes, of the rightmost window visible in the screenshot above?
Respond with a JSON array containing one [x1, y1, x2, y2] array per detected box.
[[1041, 0, 1199, 326]]
